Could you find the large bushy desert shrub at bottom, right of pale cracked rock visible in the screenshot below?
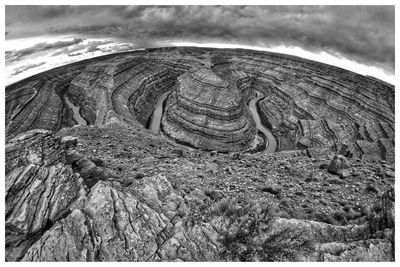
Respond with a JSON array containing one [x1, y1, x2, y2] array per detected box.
[[215, 200, 309, 261]]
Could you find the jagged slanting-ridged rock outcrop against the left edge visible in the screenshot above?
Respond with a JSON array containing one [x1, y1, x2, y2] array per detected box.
[[5, 130, 86, 261]]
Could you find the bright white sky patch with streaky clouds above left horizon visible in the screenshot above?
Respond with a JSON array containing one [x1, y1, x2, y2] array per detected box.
[[5, 36, 145, 84]]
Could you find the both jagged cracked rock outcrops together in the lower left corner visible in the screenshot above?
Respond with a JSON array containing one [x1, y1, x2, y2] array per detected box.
[[6, 130, 217, 261]]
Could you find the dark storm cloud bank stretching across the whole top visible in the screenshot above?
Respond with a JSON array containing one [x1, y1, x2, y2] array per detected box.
[[6, 6, 394, 72]]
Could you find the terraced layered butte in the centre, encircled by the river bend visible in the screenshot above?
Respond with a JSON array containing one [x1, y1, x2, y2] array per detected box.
[[162, 68, 256, 151]]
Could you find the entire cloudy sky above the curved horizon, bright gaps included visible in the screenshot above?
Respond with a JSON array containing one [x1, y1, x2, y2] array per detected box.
[[5, 6, 395, 85]]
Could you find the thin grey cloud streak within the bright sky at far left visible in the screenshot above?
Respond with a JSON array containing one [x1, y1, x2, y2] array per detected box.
[[6, 38, 83, 63]]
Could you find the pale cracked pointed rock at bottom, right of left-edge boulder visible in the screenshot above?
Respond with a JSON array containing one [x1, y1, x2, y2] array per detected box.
[[23, 177, 217, 261]]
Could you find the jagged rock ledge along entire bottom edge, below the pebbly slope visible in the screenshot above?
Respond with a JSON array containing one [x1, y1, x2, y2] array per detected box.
[[6, 130, 394, 261]]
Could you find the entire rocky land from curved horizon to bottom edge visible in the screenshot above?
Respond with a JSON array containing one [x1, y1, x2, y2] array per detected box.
[[5, 47, 395, 261]]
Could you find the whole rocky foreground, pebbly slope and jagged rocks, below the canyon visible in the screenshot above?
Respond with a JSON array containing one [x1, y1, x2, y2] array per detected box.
[[6, 123, 394, 261]]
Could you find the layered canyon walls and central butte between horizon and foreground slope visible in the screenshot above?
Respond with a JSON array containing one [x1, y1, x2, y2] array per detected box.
[[6, 47, 395, 161]]
